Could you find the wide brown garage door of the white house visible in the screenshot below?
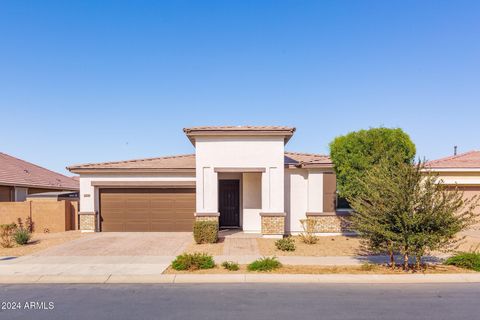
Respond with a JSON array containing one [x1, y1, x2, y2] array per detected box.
[[100, 188, 195, 232]]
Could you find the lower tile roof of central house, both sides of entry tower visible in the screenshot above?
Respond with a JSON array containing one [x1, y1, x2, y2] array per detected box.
[[67, 152, 332, 172]]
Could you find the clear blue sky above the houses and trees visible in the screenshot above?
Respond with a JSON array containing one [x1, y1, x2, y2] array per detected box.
[[0, 0, 480, 173]]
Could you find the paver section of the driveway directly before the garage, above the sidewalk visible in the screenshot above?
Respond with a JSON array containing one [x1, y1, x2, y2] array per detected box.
[[34, 232, 193, 257]]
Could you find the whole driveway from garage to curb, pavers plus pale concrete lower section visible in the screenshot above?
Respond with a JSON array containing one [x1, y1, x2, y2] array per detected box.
[[0, 232, 193, 278]]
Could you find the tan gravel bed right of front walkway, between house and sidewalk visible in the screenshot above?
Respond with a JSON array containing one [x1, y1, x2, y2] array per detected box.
[[257, 236, 361, 257]]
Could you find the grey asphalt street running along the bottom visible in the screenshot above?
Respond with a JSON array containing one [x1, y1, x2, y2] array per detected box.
[[0, 283, 480, 320]]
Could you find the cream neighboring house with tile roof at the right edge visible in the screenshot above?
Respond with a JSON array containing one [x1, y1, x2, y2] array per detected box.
[[426, 151, 480, 213]]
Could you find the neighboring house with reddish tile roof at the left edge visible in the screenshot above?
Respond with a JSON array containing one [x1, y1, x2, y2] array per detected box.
[[0, 152, 79, 202]]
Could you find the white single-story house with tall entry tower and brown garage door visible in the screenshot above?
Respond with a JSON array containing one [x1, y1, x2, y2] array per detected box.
[[67, 126, 346, 237]]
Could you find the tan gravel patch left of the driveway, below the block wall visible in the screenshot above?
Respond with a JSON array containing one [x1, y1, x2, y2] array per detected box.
[[0, 231, 81, 257]]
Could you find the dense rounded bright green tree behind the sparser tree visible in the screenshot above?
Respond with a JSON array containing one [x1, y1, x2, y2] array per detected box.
[[330, 128, 416, 198]]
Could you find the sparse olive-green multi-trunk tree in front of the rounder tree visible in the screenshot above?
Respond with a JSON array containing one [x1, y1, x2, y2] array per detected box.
[[348, 160, 478, 269]]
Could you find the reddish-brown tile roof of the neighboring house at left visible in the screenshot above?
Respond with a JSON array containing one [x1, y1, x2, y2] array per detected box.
[[0, 152, 79, 190]]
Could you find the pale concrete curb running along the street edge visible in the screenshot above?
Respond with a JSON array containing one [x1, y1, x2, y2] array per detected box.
[[0, 273, 480, 284]]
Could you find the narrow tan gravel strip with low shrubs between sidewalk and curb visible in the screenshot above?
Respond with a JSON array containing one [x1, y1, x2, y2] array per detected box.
[[164, 264, 474, 274]]
